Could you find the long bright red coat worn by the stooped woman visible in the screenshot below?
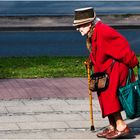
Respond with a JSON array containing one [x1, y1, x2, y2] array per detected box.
[[90, 22, 138, 117]]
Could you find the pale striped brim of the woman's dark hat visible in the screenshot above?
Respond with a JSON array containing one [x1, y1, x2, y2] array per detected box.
[[73, 17, 95, 26]]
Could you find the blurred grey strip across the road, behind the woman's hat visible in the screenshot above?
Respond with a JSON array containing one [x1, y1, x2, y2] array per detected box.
[[0, 14, 140, 30]]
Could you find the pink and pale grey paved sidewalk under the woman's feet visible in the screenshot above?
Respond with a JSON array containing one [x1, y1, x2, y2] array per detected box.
[[0, 78, 140, 139]]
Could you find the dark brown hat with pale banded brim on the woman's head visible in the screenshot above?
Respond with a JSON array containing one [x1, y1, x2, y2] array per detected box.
[[73, 7, 96, 26]]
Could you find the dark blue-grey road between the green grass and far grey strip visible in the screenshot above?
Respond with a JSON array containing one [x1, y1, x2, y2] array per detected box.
[[0, 29, 140, 57]]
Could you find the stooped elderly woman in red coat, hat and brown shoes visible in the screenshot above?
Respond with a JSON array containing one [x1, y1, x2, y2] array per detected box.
[[73, 7, 138, 139]]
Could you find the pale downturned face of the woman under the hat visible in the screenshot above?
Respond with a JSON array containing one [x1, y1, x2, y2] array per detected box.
[[76, 23, 91, 36]]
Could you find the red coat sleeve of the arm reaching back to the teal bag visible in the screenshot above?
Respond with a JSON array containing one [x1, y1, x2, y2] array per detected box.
[[102, 26, 138, 68]]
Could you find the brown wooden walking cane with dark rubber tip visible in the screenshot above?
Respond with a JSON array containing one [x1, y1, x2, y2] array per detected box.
[[84, 61, 95, 131]]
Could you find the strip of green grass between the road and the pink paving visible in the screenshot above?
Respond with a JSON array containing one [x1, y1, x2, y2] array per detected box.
[[0, 56, 140, 78]]
